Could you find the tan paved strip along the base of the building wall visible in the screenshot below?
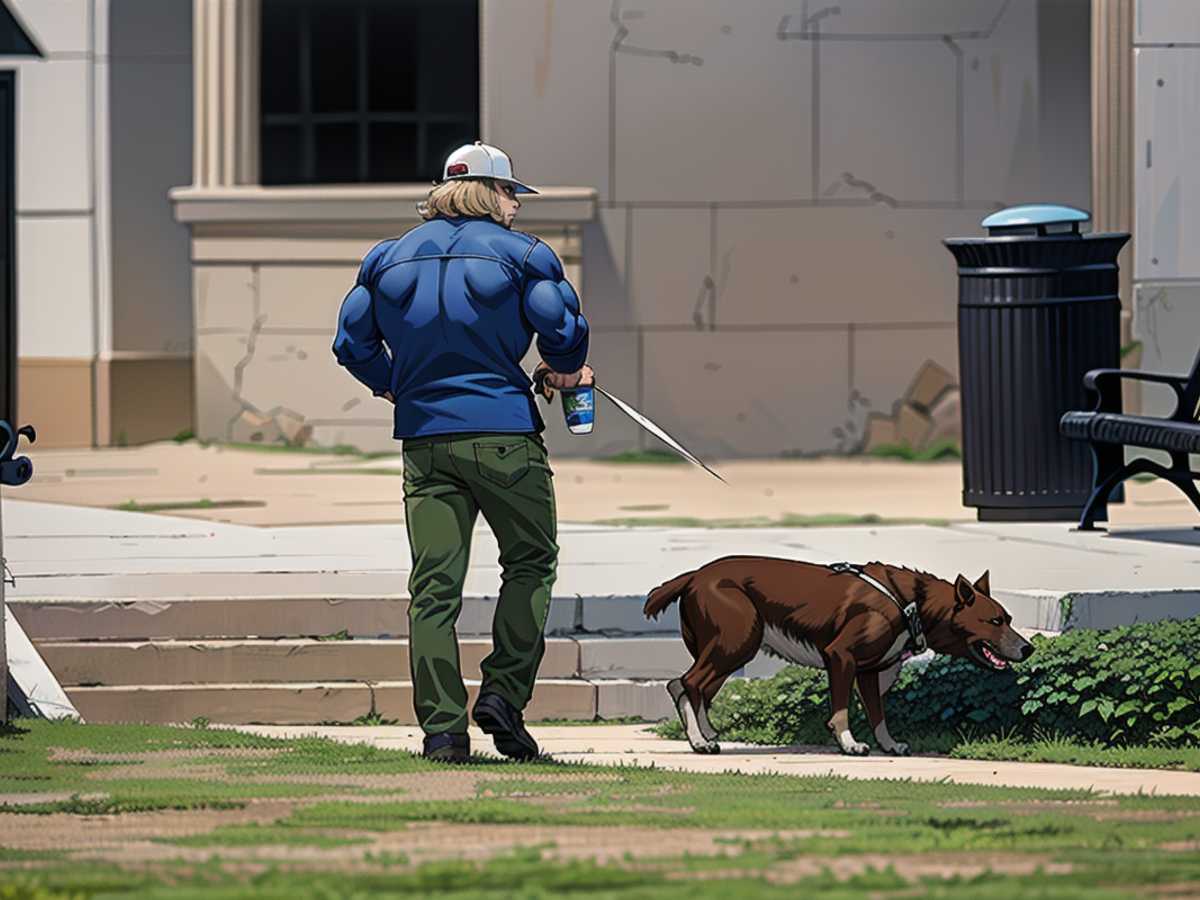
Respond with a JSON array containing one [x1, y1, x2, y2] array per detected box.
[[14, 443, 1200, 527]]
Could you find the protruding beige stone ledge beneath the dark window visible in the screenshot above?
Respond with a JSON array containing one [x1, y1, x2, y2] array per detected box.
[[169, 185, 596, 226]]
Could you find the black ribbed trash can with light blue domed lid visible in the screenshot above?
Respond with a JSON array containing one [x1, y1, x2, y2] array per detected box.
[[943, 205, 1129, 522]]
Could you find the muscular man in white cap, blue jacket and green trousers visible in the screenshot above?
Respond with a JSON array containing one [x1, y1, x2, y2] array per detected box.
[[334, 142, 593, 762]]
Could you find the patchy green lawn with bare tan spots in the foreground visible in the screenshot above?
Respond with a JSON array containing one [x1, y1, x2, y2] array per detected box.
[[0, 720, 1200, 900]]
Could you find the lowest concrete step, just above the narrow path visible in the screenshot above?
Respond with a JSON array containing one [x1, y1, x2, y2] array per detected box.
[[66, 678, 624, 725]]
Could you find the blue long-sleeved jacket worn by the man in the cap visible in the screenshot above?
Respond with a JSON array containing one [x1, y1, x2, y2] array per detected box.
[[334, 218, 588, 438]]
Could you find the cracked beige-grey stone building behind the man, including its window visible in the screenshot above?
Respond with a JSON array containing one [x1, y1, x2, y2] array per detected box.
[[0, 0, 1180, 457]]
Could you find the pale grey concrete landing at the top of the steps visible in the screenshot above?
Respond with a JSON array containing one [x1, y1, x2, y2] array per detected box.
[[4, 498, 1200, 631]]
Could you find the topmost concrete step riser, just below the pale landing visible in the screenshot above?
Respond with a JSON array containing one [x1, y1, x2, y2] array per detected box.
[[7, 595, 679, 641]]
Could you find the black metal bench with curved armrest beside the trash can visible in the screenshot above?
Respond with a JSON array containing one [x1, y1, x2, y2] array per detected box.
[[1058, 353, 1200, 530]]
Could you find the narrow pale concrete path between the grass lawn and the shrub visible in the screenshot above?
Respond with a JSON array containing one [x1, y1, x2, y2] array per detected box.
[[231, 725, 1200, 797]]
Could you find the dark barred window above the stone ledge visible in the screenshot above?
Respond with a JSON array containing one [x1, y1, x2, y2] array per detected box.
[[259, 0, 479, 185]]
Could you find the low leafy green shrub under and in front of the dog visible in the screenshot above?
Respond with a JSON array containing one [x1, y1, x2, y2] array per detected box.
[[667, 617, 1200, 749]]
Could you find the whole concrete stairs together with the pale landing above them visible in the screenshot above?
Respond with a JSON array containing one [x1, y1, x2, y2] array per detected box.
[[4, 499, 1200, 729]]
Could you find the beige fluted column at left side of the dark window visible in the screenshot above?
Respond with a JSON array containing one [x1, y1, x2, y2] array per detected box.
[[192, 0, 260, 187]]
